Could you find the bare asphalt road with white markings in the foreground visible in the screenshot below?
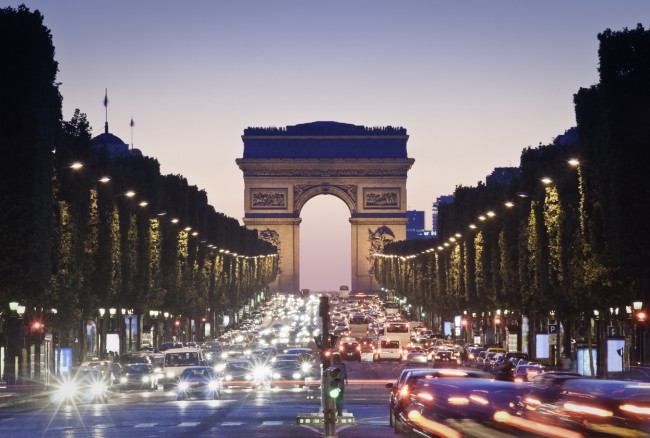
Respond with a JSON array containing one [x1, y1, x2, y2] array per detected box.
[[0, 362, 556, 438]]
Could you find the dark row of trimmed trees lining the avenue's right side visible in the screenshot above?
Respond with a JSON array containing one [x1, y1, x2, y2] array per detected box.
[[375, 25, 650, 360]]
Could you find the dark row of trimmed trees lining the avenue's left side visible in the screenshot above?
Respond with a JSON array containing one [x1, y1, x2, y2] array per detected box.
[[0, 6, 278, 348]]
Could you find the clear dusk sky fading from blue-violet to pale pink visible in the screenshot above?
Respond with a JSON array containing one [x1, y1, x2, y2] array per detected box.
[[6, 0, 650, 290]]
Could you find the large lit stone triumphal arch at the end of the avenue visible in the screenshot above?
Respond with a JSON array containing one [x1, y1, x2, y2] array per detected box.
[[237, 122, 415, 292]]
